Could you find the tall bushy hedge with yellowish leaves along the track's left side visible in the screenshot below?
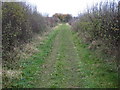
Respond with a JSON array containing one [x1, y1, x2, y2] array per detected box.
[[2, 2, 48, 68]]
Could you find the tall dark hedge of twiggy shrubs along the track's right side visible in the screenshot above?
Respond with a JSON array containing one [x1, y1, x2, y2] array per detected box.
[[72, 0, 120, 62]]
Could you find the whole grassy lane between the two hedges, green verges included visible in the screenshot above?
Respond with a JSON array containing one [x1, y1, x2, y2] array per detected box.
[[9, 24, 117, 88]]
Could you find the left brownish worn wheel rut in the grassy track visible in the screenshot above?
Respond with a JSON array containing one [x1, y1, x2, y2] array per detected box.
[[38, 27, 60, 87]]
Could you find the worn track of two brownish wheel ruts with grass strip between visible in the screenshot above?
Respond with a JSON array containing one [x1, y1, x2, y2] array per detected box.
[[37, 25, 80, 88]]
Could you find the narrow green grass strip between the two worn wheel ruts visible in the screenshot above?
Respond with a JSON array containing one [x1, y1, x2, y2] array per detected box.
[[50, 25, 69, 88]]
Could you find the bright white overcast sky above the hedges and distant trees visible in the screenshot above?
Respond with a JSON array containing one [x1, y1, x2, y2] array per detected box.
[[20, 0, 112, 16]]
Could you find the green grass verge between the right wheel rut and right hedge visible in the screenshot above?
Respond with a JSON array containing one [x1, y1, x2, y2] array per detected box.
[[73, 32, 118, 88]]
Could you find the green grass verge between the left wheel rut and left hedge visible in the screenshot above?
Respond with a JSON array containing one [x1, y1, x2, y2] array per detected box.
[[4, 27, 57, 88]]
